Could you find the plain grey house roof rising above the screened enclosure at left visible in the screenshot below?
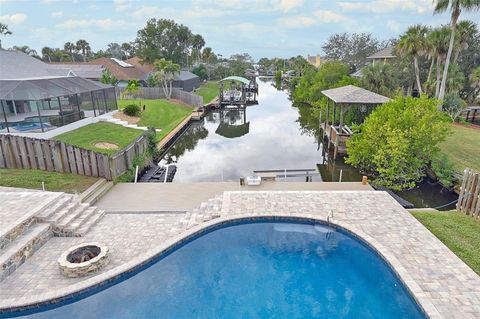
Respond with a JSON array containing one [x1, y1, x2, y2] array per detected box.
[[0, 49, 69, 80]]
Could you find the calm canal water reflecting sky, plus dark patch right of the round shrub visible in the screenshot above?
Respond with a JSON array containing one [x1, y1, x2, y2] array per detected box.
[[162, 80, 455, 207]]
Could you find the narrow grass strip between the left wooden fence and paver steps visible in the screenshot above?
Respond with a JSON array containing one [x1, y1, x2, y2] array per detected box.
[[0, 169, 98, 193]]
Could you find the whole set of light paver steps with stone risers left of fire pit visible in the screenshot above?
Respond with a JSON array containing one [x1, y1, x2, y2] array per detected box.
[[0, 192, 105, 281]]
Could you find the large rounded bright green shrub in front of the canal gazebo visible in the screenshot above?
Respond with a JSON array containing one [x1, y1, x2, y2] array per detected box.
[[346, 96, 448, 190]]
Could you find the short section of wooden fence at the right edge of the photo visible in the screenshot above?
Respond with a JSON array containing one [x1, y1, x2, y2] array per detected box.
[[457, 168, 480, 218]]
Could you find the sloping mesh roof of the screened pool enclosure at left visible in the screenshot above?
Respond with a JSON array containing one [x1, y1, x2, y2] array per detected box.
[[0, 76, 113, 100]]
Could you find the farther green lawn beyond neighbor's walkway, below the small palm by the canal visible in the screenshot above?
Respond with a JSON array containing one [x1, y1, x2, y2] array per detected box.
[[118, 100, 193, 141]]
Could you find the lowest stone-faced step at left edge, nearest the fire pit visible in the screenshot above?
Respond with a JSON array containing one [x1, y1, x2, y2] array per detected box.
[[0, 223, 53, 281]]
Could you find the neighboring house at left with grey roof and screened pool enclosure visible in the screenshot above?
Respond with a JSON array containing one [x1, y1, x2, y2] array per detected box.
[[0, 49, 117, 133]]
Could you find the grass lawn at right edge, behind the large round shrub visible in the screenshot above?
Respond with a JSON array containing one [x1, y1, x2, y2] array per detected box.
[[440, 125, 480, 173]]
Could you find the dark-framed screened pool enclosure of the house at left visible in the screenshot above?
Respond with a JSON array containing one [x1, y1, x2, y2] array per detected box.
[[0, 76, 117, 133]]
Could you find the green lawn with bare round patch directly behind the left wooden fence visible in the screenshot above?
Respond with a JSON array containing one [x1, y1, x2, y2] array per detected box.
[[52, 122, 143, 155]]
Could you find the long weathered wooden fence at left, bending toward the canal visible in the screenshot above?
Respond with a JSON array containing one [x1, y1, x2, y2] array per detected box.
[[0, 134, 148, 180]]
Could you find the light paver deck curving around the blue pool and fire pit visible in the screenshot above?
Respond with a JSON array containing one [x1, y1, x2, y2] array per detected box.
[[0, 190, 480, 318]]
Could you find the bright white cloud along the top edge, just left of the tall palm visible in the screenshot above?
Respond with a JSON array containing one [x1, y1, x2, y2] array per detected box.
[[338, 0, 434, 14]]
